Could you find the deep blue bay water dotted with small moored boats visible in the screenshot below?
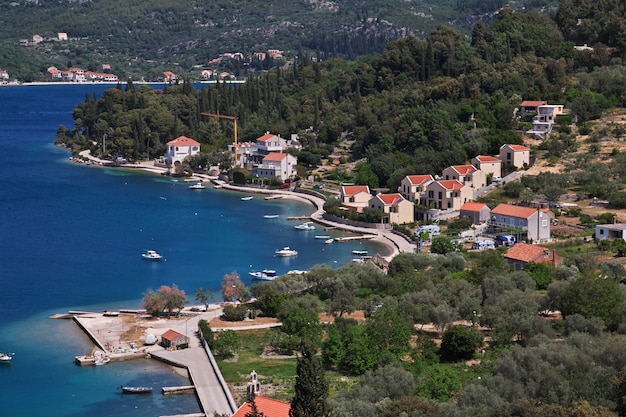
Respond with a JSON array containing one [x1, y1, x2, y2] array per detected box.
[[0, 84, 386, 417]]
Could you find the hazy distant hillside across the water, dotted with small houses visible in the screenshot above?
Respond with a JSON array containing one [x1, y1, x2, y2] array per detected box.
[[0, 0, 556, 81]]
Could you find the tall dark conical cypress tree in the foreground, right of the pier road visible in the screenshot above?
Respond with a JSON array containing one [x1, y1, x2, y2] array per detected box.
[[289, 341, 328, 417]]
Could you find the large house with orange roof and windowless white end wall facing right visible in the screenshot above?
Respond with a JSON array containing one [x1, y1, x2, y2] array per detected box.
[[489, 203, 552, 242]]
